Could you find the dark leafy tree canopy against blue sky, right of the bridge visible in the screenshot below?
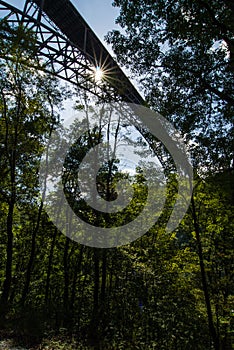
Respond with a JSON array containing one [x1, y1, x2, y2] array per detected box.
[[107, 0, 234, 171]]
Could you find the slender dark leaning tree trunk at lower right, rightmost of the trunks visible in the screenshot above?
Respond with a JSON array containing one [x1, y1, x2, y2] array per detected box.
[[191, 196, 220, 350]]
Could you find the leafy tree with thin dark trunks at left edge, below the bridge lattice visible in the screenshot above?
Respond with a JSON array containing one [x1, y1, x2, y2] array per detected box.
[[0, 22, 66, 316]]
